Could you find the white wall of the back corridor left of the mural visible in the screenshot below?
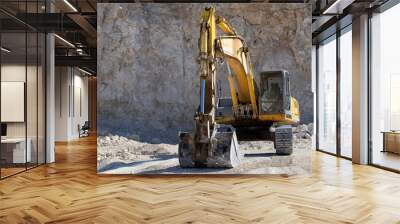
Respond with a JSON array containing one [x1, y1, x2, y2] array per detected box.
[[55, 67, 88, 141]]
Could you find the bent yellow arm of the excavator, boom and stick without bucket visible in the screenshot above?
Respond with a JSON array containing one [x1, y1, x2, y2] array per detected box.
[[199, 7, 257, 126]]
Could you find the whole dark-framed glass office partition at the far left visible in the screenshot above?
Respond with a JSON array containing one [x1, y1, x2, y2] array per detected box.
[[0, 0, 45, 178]]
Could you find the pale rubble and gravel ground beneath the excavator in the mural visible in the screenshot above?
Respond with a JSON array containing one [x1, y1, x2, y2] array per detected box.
[[97, 126, 312, 175]]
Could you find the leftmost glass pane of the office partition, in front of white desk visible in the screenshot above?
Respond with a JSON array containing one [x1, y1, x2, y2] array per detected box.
[[1, 32, 30, 178]]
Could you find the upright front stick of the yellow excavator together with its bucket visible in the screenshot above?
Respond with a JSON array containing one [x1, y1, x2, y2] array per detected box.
[[178, 7, 243, 168]]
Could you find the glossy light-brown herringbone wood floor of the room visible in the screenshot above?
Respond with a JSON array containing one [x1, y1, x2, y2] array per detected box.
[[0, 137, 400, 224]]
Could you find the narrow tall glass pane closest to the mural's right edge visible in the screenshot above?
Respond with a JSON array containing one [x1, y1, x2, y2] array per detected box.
[[318, 38, 336, 156]]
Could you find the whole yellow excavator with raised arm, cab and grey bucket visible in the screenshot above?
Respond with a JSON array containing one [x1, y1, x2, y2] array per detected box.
[[178, 7, 300, 168]]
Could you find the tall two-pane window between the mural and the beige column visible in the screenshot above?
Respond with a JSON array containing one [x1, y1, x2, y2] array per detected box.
[[316, 24, 353, 159]]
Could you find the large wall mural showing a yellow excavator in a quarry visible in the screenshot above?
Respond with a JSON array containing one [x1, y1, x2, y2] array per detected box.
[[97, 3, 314, 175]]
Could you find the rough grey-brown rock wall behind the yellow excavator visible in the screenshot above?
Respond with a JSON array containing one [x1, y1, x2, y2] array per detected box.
[[97, 3, 313, 143]]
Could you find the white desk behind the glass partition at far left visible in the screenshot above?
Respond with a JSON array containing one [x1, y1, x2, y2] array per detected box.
[[1, 138, 32, 163]]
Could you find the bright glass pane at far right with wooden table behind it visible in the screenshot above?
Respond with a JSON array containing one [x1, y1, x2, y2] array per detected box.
[[371, 5, 400, 170]]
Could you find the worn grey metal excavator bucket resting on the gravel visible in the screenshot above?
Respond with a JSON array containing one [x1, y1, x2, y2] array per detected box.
[[178, 124, 241, 168]]
